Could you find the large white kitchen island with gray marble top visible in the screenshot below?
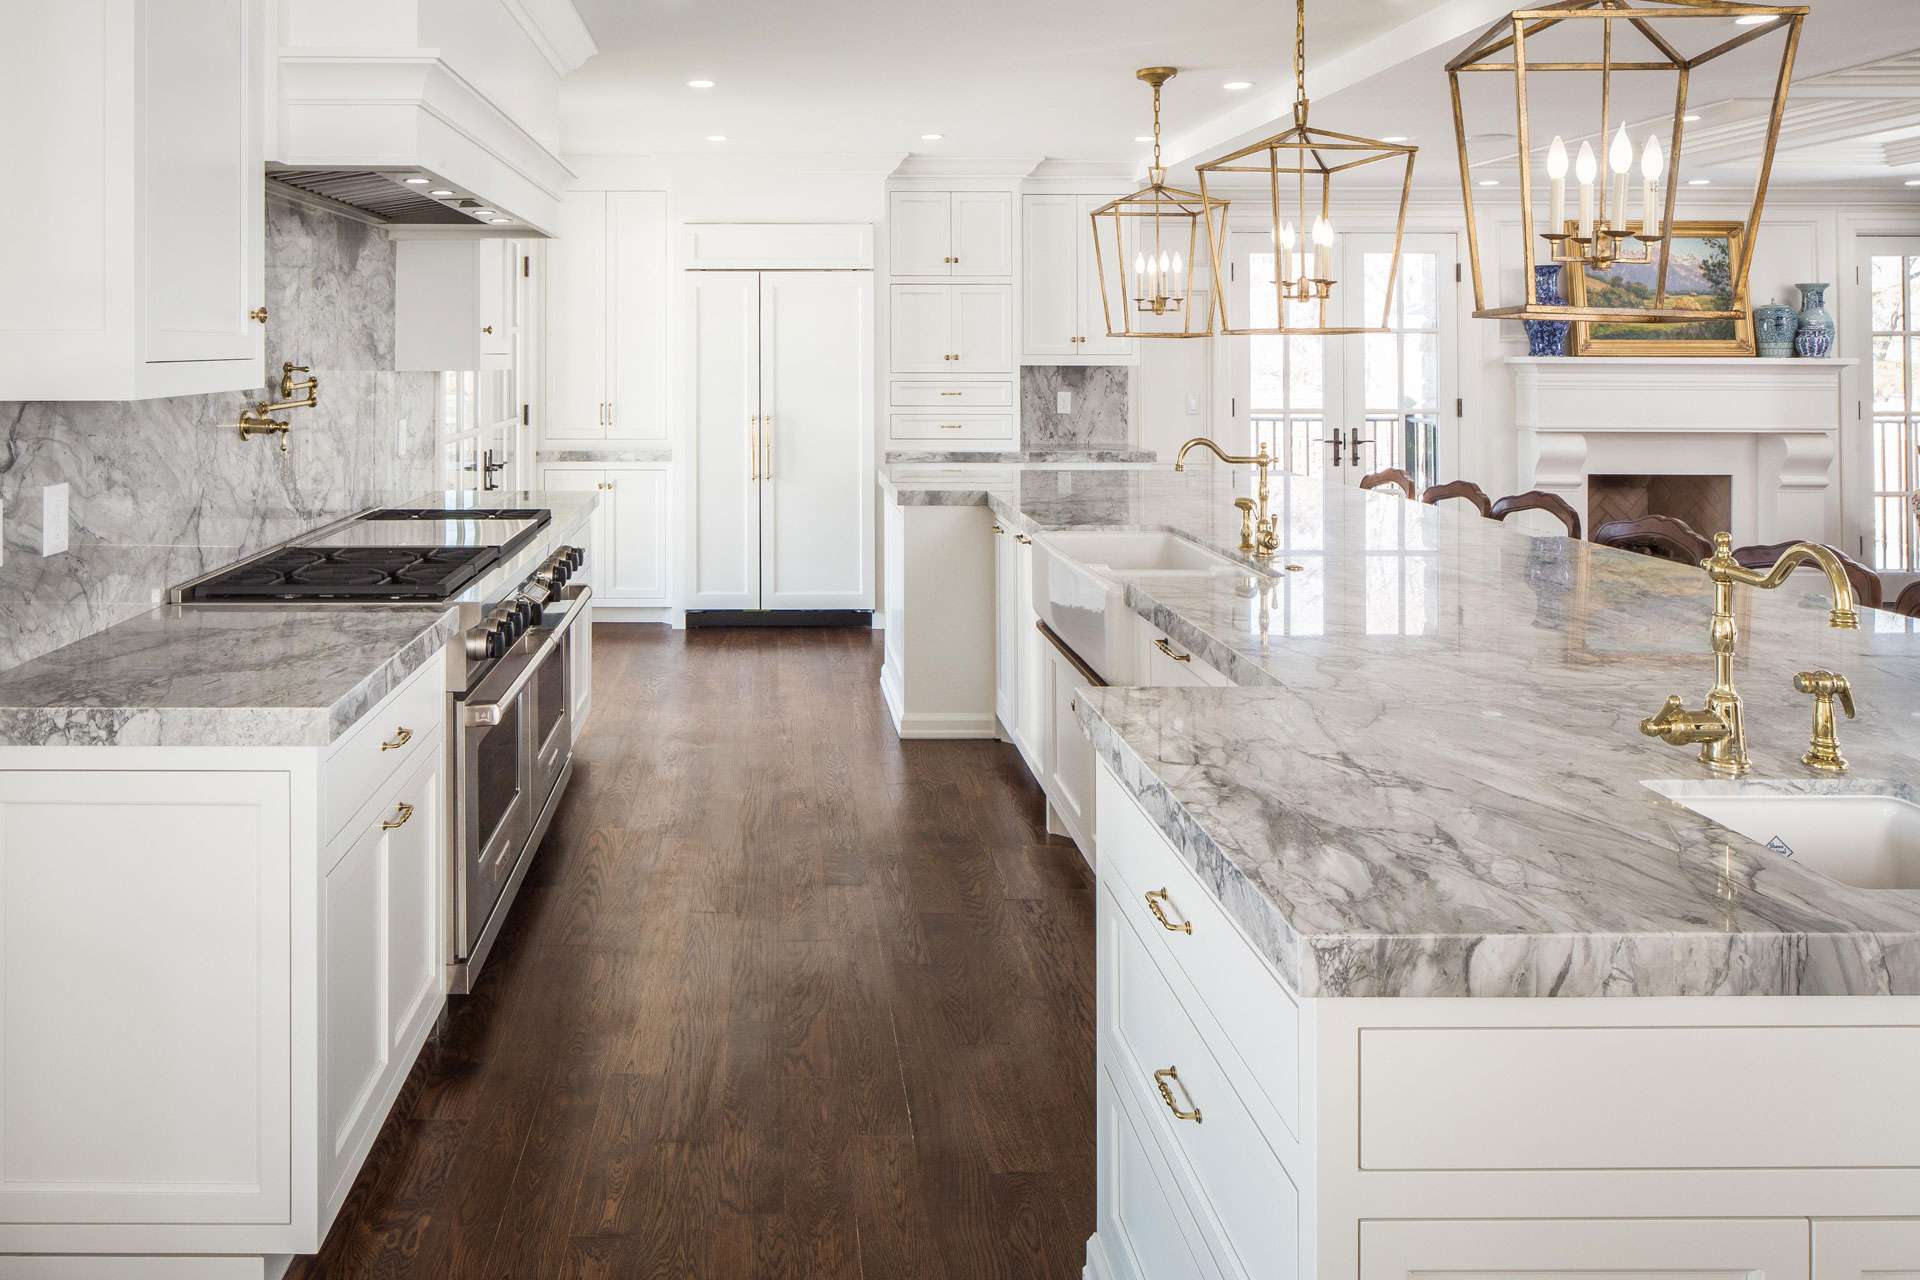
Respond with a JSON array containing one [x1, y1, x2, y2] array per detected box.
[[879, 468, 1920, 1280]]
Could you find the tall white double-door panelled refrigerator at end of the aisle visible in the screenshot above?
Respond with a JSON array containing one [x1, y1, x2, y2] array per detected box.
[[685, 271, 874, 610]]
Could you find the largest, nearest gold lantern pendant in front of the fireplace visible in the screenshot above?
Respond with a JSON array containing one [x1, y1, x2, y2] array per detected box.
[[1448, 0, 1807, 324]]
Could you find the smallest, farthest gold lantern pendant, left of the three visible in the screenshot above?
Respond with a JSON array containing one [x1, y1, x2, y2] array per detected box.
[[1092, 67, 1227, 338]]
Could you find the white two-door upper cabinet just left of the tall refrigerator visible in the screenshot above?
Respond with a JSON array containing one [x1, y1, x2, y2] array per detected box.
[[545, 192, 666, 441]]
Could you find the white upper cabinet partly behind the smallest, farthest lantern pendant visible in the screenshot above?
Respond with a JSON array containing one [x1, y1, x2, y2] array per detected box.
[[1020, 194, 1137, 365]]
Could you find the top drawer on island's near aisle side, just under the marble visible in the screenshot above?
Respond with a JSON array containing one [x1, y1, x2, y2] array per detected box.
[[1096, 766, 1300, 1138]]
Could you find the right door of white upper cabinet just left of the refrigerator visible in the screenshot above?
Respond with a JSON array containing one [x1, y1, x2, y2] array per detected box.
[[607, 192, 666, 439]]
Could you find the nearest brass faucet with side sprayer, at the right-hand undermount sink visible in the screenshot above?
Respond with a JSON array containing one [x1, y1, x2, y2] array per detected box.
[[1640, 533, 1860, 777]]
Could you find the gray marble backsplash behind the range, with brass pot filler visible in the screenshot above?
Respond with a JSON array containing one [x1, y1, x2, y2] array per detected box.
[[0, 198, 436, 670]]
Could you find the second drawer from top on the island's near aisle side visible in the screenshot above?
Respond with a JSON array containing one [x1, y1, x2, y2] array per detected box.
[[1098, 883, 1300, 1276]]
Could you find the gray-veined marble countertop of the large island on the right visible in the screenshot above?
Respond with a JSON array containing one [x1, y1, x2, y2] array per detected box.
[[893, 466, 1920, 996]]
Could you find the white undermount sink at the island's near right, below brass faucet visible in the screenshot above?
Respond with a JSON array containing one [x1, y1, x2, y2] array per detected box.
[[1649, 783, 1920, 889]]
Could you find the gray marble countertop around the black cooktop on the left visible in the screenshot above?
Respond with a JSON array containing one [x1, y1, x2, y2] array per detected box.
[[0, 491, 597, 747]]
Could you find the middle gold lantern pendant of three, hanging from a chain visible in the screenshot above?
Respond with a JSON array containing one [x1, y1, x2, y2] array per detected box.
[[1196, 0, 1419, 336]]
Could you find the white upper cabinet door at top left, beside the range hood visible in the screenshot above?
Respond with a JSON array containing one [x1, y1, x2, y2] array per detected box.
[[134, 0, 265, 363]]
